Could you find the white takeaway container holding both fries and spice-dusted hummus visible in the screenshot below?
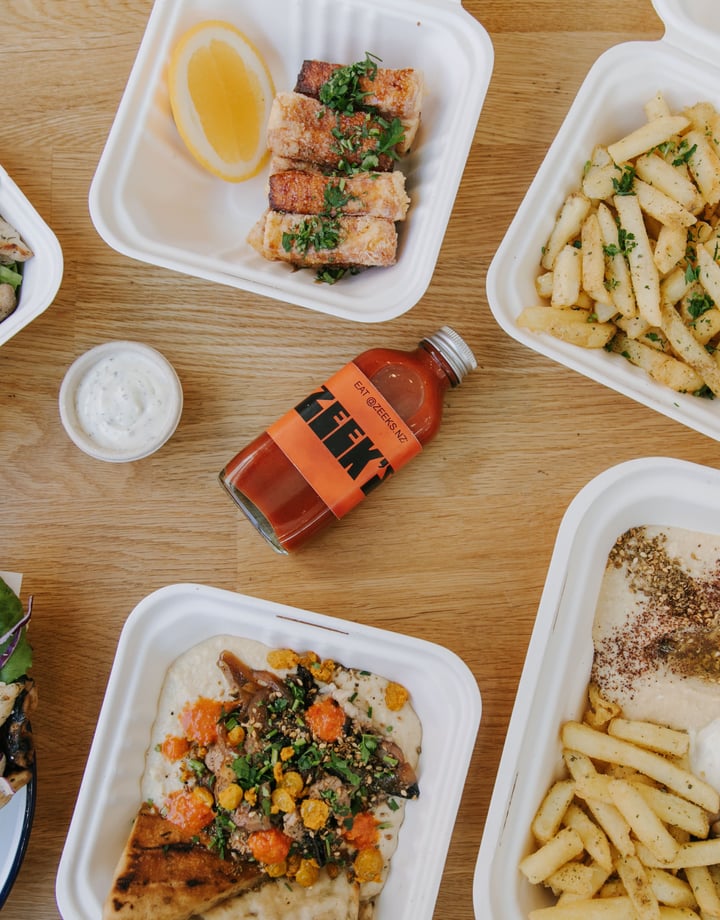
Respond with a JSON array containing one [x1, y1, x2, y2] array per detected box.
[[473, 457, 720, 920]]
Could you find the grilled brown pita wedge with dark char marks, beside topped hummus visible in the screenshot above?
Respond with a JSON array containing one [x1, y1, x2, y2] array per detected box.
[[103, 806, 262, 920]]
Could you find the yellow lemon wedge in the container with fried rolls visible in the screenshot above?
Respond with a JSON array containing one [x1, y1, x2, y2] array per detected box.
[[168, 20, 275, 182]]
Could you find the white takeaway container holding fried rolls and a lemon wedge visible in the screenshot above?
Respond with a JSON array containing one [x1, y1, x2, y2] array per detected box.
[[90, 0, 493, 323]]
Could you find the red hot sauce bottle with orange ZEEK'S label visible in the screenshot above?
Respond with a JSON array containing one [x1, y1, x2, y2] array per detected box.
[[220, 326, 477, 553]]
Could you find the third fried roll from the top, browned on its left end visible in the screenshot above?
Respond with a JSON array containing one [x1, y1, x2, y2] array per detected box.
[[268, 169, 410, 220]]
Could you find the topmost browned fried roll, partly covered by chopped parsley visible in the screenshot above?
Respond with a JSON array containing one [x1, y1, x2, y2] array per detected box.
[[295, 60, 424, 152]]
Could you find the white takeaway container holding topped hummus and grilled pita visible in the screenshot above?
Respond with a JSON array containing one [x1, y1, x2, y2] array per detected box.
[[56, 584, 481, 920]]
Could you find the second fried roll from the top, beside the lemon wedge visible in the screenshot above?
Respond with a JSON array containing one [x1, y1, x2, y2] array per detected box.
[[267, 93, 394, 172]]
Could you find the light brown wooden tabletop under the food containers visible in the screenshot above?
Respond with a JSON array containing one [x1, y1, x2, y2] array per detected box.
[[0, 0, 718, 920]]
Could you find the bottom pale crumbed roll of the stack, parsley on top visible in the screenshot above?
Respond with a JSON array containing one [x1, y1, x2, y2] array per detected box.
[[248, 211, 397, 268]]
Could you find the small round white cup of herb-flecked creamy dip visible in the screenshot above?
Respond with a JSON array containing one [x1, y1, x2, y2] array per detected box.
[[60, 342, 182, 461]]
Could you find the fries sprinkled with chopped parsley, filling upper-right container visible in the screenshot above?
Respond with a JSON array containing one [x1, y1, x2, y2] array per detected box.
[[517, 93, 720, 397]]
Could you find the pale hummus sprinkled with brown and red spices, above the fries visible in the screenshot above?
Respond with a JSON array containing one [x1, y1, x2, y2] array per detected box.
[[592, 526, 720, 790]]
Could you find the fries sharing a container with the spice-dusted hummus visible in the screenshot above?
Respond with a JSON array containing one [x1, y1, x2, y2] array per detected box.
[[519, 684, 720, 920]]
